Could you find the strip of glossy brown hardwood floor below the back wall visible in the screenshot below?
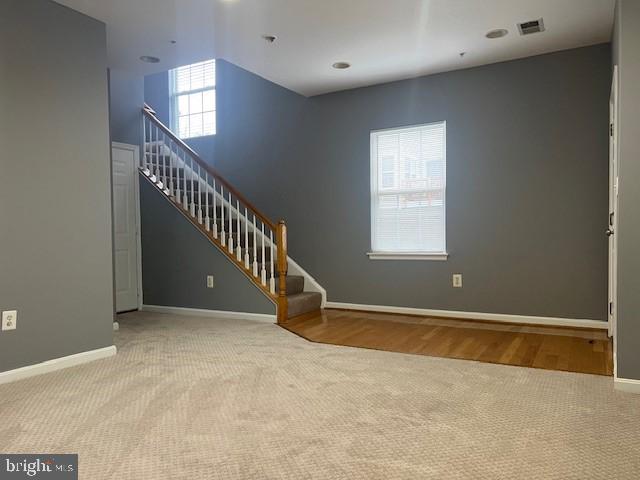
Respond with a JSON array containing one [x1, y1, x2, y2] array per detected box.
[[283, 309, 613, 375]]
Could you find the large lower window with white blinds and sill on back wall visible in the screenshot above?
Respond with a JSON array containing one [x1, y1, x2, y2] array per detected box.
[[368, 122, 447, 260]]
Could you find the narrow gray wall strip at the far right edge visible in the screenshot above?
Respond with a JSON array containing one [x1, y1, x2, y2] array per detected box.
[[614, 0, 640, 379]]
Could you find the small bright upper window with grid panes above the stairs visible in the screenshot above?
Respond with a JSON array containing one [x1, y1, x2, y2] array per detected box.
[[169, 60, 216, 138]]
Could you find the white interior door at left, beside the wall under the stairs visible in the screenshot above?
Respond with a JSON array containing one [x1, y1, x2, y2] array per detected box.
[[111, 143, 139, 312]]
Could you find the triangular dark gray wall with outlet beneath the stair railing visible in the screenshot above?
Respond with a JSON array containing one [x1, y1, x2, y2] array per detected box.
[[140, 178, 275, 315]]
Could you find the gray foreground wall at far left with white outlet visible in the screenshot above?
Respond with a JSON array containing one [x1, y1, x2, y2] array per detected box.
[[0, 0, 113, 371]]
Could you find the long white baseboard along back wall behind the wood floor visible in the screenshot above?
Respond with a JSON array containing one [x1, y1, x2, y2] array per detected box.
[[326, 302, 607, 330]]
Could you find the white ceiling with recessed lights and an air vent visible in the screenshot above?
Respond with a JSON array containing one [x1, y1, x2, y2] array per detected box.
[[57, 0, 615, 96]]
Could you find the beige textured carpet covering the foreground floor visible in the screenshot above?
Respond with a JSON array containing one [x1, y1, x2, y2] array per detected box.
[[0, 313, 640, 480]]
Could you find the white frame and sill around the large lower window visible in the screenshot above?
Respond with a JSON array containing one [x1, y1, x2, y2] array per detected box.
[[367, 120, 449, 261]]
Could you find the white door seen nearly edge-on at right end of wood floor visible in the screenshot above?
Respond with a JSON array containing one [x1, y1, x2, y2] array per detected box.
[[606, 66, 618, 342]]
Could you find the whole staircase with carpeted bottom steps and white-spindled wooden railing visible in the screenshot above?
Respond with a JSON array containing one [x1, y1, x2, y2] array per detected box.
[[139, 105, 322, 324]]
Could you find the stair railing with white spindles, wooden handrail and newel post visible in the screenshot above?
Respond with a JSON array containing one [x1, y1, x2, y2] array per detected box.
[[140, 105, 286, 322]]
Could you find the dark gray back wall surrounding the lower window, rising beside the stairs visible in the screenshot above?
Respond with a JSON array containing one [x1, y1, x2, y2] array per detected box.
[[145, 44, 611, 320]]
